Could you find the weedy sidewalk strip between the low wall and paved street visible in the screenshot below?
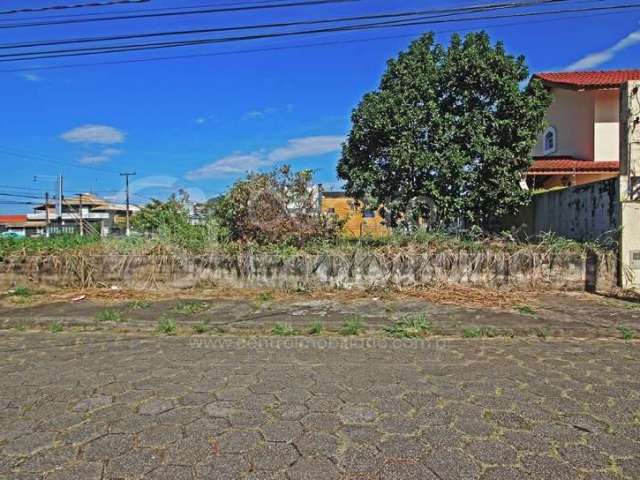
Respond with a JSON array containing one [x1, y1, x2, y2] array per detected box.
[[0, 293, 640, 338]]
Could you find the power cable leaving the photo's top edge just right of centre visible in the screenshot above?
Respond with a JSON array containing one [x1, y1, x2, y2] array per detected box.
[[0, 0, 361, 28]]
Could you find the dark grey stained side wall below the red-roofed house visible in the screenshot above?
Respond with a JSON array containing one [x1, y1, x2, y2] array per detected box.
[[503, 178, 620, 241]]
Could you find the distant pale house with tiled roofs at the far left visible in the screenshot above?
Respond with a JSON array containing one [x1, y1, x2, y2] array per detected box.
[[0, 193, 140, 236]]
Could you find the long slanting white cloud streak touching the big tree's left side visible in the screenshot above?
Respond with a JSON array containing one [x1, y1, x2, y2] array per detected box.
[[186, 135, 344, 180]]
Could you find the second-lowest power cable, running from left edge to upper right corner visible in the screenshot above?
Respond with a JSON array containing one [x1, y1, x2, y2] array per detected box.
[[0, 2, 640, 62]]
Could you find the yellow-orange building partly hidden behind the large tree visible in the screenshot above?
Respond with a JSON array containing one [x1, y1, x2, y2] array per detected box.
[[320, 192, 389, 238]]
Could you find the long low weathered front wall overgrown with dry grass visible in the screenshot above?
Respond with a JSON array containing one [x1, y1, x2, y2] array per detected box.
[[0, 251, 617, 291]]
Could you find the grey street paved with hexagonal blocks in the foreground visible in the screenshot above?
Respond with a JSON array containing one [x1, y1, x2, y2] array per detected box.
[[0, 332, 640, 480]]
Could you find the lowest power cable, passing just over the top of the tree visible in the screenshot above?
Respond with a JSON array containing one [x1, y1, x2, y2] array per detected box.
[[0, 5, 626, 73]]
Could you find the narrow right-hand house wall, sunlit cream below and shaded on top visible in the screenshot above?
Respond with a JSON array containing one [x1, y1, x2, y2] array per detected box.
[[593, 89, 620, 162]]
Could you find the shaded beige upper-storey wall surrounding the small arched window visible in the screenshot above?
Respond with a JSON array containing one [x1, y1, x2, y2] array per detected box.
[[533, 88, 592, 160]]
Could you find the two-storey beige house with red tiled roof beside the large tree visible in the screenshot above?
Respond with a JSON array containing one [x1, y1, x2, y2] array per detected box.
[[527, 70, 640, 189]]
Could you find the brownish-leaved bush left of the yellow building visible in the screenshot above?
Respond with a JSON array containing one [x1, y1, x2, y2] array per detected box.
[[213, 166, 340, 246]]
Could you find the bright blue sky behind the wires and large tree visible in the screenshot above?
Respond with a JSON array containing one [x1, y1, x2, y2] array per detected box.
[[0, 0, 640, 213]]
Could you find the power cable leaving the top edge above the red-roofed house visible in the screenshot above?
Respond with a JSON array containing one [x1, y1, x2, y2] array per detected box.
[[0, 0, 580, 49]]
